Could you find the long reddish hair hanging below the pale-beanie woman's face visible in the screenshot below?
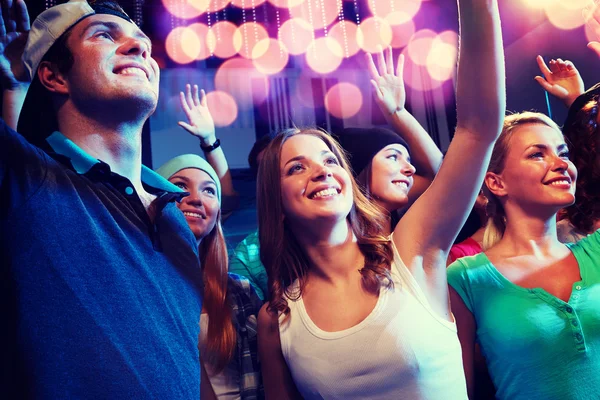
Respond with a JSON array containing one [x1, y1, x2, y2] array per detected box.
[[198, 210, 236, 373]]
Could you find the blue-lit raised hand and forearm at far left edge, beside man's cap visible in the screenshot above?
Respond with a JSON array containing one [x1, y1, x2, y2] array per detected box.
[[0, 0, 30, 129]]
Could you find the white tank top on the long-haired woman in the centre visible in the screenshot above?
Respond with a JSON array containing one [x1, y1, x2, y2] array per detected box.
[[279, 244, 467, 400]]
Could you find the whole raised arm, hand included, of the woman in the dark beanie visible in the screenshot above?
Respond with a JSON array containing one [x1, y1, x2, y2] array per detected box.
[[366, 47, 443, 202]]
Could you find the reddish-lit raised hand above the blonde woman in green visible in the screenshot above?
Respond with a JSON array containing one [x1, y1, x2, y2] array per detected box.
[[535, 56, 585, 107]]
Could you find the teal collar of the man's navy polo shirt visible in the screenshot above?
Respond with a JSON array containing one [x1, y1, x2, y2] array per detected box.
[[46, 131, 185, 193]]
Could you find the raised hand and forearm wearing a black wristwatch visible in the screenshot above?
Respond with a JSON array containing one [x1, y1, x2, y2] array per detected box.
[[178, 84, 237, 197]]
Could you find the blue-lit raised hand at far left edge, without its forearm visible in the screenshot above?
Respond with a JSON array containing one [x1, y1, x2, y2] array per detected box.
[[0, 0, 30, 90]]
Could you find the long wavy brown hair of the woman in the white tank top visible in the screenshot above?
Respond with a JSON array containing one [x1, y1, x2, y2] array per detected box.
[[257, 129, 394, 315]]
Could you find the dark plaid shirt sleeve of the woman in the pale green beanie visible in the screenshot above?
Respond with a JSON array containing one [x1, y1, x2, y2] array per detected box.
[[227, 273, 265, 400]]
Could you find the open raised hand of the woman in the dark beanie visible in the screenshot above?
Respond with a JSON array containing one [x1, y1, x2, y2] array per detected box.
[[366, 47, 406, 117]]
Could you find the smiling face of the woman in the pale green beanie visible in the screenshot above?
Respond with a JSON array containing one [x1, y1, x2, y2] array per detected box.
[[169, 168, 220, 242]]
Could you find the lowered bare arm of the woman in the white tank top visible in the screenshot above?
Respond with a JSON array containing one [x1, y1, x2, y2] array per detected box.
[[258, 303, 302, 400]]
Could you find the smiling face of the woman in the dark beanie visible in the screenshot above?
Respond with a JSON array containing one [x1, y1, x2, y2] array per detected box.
[[369, 144, 415, 212]]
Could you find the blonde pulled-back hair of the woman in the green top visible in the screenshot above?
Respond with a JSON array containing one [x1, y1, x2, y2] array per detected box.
[[483, 111, 560, 250]]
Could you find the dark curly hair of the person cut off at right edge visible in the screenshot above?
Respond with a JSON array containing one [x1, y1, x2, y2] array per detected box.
[[563, 94, 600, 233]]
